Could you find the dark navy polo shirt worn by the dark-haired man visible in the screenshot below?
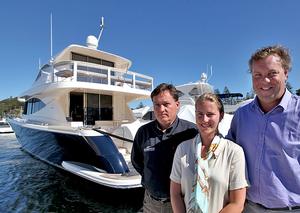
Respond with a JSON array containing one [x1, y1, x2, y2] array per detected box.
[[131, 117, 198, 198]]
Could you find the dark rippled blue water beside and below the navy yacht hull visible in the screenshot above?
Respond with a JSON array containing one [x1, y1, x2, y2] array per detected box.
[[0, 134, 143, 213]]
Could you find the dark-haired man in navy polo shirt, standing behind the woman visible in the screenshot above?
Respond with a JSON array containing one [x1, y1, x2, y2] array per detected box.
[[131, 83, 198, 213]]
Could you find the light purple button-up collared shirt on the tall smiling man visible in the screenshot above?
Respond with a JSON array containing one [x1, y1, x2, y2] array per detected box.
[[226, 90, 300, 208]]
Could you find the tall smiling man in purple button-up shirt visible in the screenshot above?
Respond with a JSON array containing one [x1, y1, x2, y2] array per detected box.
[[227, 45, 300, 213]]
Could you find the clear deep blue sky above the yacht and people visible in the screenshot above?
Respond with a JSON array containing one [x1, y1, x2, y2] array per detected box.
[[0, 0, 300, 100]]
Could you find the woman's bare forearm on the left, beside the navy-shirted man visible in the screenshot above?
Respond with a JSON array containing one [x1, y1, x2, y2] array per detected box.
[[170, 180, 185, 213]]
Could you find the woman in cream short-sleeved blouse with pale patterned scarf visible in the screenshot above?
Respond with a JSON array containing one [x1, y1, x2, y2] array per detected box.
[[170, 93, 248, 213]]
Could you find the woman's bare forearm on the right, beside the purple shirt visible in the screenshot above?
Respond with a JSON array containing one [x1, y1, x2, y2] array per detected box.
[[220, 188, 246, 213]]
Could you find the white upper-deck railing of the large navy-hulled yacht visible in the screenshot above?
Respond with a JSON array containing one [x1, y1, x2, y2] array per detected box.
[[53, 61, 153, 91]]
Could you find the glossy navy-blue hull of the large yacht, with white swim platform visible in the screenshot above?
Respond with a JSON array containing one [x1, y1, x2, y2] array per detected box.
[[9, 120, 141, 188]]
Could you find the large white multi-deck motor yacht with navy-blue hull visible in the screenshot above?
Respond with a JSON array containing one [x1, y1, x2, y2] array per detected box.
[[8, 18, 153, 189]]
